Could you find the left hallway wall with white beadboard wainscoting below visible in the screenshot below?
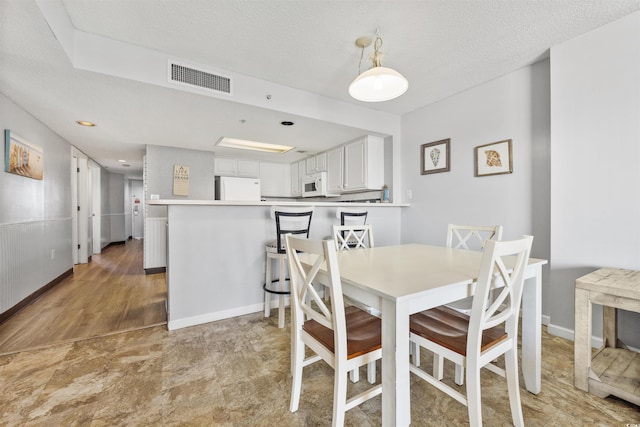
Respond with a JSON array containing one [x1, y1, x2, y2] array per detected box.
[[0, 94, 73, 313]]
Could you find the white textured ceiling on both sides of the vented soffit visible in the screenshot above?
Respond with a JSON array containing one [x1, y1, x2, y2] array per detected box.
[[0, 0, 640, 177]]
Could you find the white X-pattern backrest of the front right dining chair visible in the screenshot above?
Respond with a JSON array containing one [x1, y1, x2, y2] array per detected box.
[[467, 236, 533, 356]]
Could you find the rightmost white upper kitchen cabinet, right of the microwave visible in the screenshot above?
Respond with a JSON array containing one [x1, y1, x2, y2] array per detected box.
[[343, 135, 384, 191]]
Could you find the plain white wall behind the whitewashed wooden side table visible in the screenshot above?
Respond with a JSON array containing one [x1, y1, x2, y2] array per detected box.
[[550, 12, 640, 346]]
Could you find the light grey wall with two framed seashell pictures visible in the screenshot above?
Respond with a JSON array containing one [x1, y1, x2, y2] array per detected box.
[[402, 61, 549, 258]]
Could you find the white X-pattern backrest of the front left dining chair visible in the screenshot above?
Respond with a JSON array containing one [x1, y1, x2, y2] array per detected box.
[[285, 235, 347, 358]]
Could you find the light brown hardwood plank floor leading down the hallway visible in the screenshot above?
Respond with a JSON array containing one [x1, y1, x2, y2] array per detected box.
[[0, 240, 167, 354]]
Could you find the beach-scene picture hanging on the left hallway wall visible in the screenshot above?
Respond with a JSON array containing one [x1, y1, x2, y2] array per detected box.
[[4, 129, 44, 180]]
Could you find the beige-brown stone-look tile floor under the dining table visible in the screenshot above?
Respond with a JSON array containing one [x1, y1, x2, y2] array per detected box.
[[0, 313, 640, 427]]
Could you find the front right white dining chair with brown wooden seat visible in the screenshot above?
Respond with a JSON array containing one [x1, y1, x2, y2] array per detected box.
[[409, 236, 533, 427]]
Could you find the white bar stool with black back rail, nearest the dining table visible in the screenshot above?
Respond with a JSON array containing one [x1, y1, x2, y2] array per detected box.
[[262, 206, 313, 328]]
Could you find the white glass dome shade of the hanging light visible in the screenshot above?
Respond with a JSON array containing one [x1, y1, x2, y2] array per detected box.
[[349, 67, 409, 102]]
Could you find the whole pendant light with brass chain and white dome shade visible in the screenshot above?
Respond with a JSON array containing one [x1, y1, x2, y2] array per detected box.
[[349, 33, 409, 102]]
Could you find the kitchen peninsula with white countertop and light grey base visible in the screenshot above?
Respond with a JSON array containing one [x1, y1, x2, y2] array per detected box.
[[147, 200, 409, 330]]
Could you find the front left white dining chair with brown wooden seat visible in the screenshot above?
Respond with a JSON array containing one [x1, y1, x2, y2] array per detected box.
[[286, 235, 382, 426]]
